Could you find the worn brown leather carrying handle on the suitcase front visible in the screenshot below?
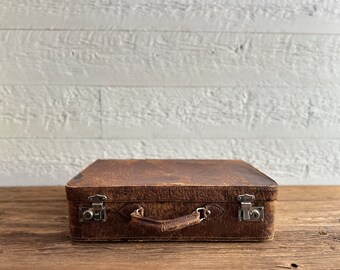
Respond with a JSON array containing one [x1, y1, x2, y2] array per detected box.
[[130, 206, 210, 232]]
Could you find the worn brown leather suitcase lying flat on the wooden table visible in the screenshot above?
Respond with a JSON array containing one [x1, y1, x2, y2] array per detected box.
[[66, 160, 277, 241]]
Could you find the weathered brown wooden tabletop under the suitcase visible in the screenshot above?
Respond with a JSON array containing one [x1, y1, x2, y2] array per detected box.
[[0, 186, 340, 270]]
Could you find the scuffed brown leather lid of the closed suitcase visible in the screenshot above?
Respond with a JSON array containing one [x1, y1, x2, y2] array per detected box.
[[66, 159, 277, 202]]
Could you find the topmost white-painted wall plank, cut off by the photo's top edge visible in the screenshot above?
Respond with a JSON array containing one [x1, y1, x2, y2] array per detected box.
[[0, 0, 340, 34]]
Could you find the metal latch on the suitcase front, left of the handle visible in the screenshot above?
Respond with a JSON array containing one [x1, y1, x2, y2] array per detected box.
[[79, 194, 107, 222]]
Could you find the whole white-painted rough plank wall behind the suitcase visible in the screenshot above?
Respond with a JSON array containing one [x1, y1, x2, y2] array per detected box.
[[0, 0, 340, 186]]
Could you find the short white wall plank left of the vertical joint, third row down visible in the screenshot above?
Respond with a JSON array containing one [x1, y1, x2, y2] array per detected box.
[[0, 86, 101, 138]]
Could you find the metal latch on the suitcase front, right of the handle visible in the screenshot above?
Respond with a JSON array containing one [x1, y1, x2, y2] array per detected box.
[[237, 194, 264, 221]]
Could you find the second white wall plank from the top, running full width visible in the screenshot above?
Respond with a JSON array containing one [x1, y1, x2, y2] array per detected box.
[[0, 30, 340, 87]]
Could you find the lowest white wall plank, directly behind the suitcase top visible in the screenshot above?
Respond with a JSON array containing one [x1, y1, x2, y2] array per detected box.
[[0, 139, 340, 186]]
